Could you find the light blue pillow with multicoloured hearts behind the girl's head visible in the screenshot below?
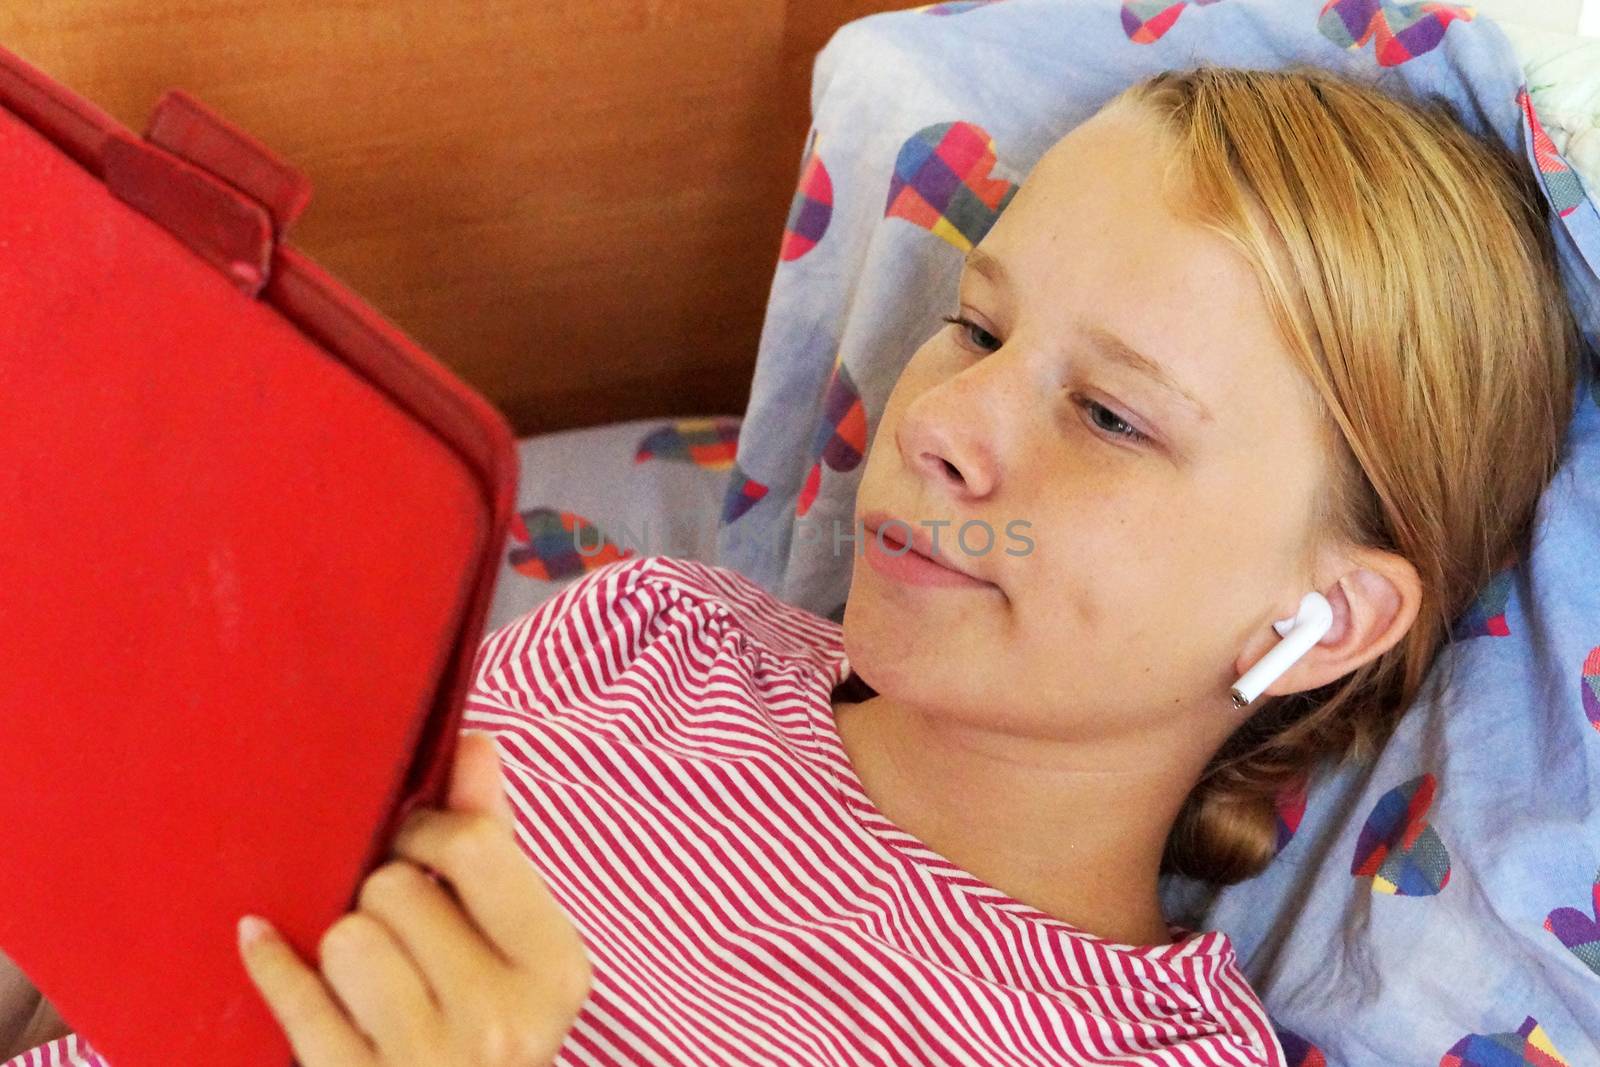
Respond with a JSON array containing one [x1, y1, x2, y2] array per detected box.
[[717, 0, 1600, 1067]]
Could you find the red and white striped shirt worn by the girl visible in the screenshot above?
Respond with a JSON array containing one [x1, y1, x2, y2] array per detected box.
[[5, 557, 1285, 1067]]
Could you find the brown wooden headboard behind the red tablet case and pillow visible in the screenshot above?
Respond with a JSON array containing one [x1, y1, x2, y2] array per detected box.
[[0, 0, 912, 434]]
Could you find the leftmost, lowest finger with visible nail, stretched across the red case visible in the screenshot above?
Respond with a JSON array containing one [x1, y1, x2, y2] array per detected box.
[[238, 925, 376, 1067]]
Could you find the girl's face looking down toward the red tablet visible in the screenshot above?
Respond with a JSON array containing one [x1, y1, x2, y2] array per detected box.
[[843, 109, 1328, 737]]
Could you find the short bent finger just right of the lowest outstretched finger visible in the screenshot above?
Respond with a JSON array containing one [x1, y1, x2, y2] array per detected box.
[[317, 912, 443, 1062]]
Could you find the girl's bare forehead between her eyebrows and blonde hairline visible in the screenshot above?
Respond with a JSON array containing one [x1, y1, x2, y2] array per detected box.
[[979, 107, 1315, 428]]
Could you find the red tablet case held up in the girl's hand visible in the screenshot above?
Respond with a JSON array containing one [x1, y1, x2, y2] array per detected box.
[[0, 50, 517, 1067]]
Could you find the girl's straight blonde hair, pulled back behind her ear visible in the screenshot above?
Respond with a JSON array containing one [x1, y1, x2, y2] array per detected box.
[[1112, 66, 1581, 885]]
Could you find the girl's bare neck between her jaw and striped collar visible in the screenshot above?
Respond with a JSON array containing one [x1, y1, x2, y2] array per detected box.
[[834, 696, 1202, 945]]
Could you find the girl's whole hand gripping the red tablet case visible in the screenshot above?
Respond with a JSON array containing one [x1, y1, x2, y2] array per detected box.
[[240, 733, 592, 1067]]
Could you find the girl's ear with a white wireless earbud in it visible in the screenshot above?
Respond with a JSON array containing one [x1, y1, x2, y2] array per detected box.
[[1234, 545, 1422, 697]]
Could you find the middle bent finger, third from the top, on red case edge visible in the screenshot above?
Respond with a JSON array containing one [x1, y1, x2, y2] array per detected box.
[[357, 859, 507, 1016]]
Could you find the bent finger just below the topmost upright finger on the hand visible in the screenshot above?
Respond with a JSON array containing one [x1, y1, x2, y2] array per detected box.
[[394, 808, 582, 968]]
